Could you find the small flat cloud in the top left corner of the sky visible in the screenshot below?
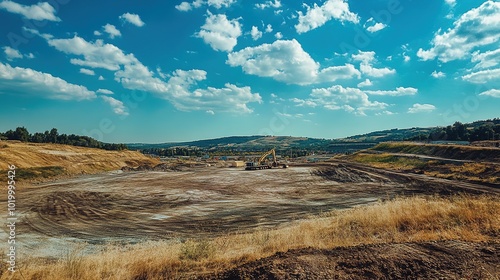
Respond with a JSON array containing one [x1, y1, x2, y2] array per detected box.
[[0, 0, 61, 21]]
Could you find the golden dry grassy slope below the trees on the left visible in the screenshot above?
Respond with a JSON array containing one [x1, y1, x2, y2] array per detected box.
[[0, 141, 159, 181]]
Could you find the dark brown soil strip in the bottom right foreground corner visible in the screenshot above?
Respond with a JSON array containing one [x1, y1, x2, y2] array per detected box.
[[204, 241, 500, 280]]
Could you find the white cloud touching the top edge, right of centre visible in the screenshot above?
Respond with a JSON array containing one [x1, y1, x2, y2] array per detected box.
[[295, 0, 359, 33]]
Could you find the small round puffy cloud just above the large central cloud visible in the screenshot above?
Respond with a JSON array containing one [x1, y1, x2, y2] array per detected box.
[[196, 12, 241, 52]]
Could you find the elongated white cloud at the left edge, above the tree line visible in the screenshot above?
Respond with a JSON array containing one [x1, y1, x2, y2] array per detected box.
[[0, 62, 96, 100]]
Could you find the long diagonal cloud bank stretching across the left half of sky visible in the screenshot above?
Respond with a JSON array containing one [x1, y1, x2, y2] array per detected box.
[[39, 35, 262, 113]]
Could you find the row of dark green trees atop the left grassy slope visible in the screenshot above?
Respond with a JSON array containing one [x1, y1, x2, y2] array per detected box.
[[0, 127, 127, 151]]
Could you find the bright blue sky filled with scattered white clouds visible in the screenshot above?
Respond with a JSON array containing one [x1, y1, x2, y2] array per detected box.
[[0, 0, 500, 143]]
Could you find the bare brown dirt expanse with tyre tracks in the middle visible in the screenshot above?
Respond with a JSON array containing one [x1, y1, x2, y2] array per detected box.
[[6, 162, 499, 257]]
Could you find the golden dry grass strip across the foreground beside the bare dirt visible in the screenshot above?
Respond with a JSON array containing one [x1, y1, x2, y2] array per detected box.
[[4, 196, 500, 280]]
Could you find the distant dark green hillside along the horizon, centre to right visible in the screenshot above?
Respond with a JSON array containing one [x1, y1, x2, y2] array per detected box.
[[127, 119, 500, 155]]
